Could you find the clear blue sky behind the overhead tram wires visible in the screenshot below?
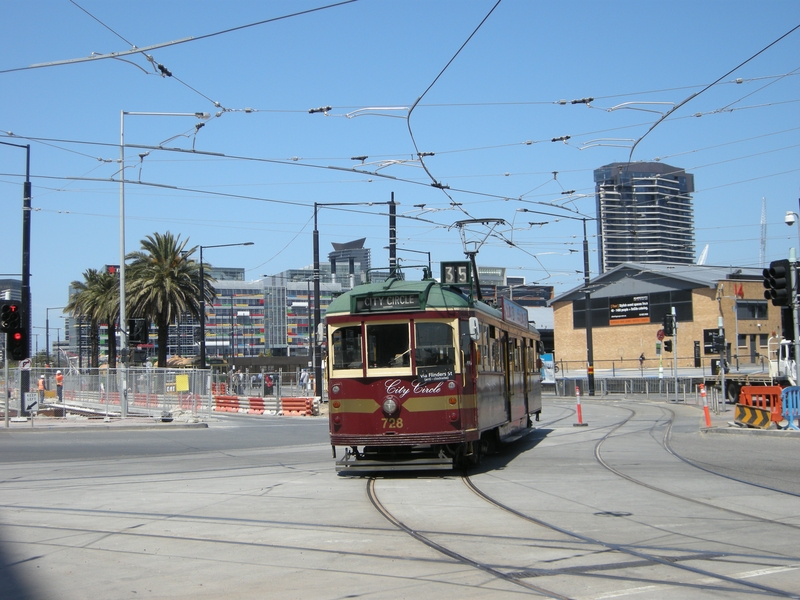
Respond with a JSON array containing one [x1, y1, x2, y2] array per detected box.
[[0, 0, 800, 340]]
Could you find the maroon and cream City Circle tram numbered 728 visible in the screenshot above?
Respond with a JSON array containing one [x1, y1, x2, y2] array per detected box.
[[326, 262, 542, 471]]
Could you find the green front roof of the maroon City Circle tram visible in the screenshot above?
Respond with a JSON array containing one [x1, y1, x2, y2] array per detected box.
[[326, 278, 501, 318]]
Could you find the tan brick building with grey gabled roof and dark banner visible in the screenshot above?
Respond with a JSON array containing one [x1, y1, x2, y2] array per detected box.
[[550, 263, 782, 370]]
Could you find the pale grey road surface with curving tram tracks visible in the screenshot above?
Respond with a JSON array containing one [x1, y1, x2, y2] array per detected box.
[[0, 398, 800, 600]]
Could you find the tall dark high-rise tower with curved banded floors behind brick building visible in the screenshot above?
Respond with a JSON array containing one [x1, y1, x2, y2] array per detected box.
[[594, 162, 695, 273]]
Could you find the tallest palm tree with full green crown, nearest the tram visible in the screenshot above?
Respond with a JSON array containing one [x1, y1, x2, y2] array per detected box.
[[126, 231, 216, 367]]
